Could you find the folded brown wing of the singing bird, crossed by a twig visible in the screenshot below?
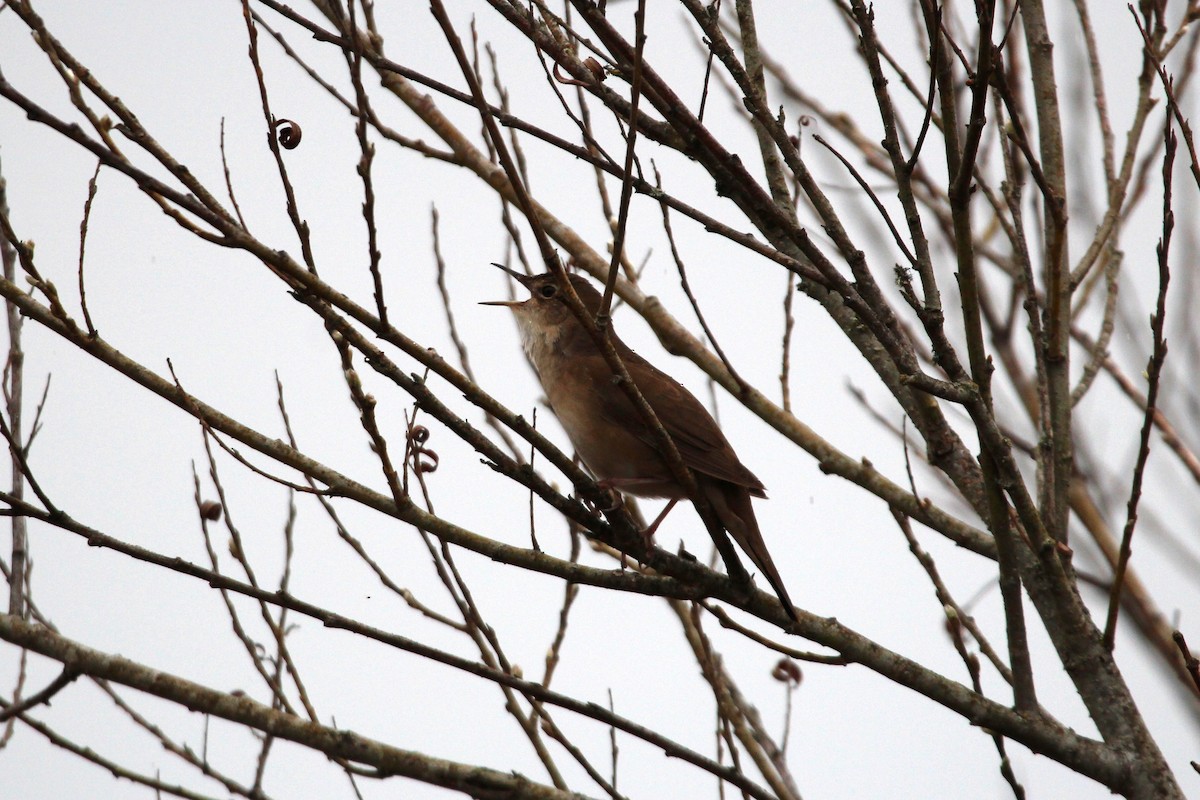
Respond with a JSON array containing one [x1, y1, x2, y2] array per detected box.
[[595, 348, 766, 497]]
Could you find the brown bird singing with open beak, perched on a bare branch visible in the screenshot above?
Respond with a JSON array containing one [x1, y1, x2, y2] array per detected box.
[[484, 264, 796, 620]]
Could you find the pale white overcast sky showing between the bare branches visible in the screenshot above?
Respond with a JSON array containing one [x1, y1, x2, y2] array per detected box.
[[0, 0, 1200, 800]]
